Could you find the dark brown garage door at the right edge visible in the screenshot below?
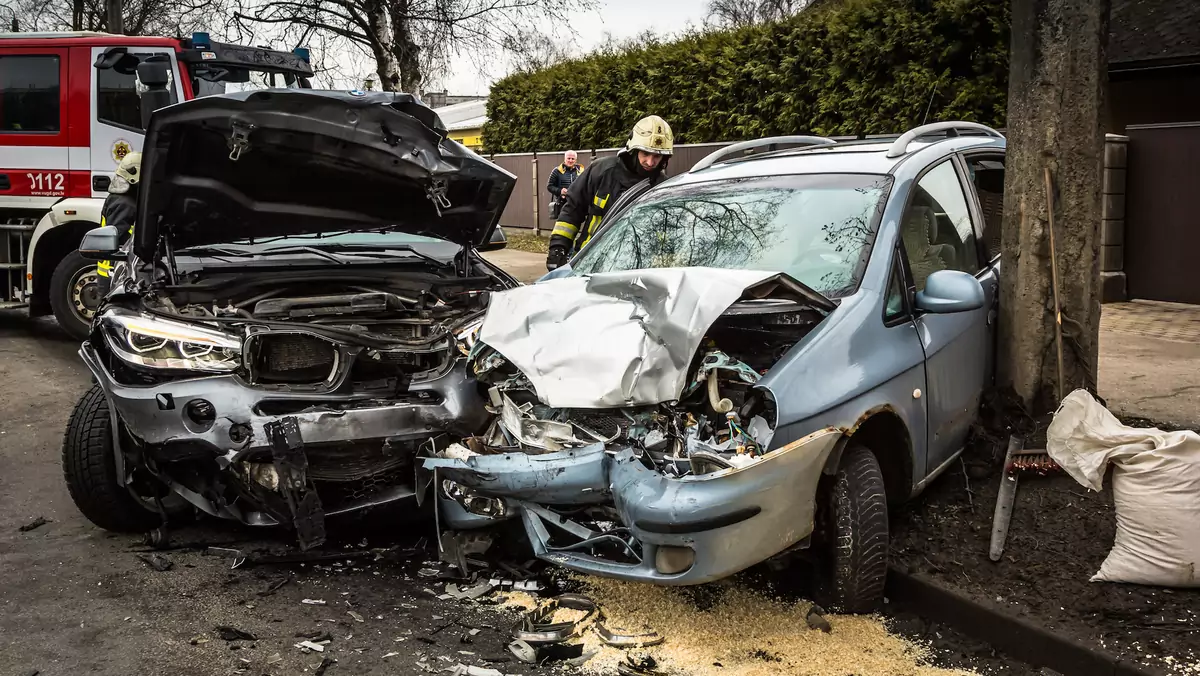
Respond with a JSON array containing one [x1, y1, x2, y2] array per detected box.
[[1124, 122, 1200, 304]]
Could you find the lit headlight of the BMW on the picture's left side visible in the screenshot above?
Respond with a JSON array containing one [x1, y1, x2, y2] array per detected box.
[[101, 309, 241, 373]]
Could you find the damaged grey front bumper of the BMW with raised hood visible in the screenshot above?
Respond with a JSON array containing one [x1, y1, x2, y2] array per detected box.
[[79, 343, 486, 531]]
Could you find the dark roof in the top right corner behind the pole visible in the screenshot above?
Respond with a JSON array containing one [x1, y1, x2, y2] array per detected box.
[[1109, 0, 1200, 71]]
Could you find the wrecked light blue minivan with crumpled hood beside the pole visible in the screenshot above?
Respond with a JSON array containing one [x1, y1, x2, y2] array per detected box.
[[418, 122, 1004, 611]]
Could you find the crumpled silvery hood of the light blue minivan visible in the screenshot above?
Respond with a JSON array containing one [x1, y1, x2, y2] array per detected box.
[[479, 268, 834, 408]]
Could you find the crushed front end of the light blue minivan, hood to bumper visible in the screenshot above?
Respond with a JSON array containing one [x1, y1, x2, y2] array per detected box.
[[418, 269, 842, 585]]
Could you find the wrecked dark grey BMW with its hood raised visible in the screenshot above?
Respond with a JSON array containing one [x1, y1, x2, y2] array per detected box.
[[62, 90, 517, 548]]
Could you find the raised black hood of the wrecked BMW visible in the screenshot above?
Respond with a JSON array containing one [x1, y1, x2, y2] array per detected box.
[[133, 90, 516, 259]]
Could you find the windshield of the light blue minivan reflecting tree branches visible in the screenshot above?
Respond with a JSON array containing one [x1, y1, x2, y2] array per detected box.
[[571, 174, 892, 298]]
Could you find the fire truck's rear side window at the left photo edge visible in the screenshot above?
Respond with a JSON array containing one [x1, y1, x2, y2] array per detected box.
[[0, 55, 59, 133]]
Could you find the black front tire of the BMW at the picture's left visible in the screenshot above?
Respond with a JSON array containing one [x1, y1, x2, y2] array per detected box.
[[62, 385, 162, 533]]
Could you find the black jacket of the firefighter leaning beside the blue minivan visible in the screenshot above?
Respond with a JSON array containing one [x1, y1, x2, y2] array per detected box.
[[550, 150, 667, 252]]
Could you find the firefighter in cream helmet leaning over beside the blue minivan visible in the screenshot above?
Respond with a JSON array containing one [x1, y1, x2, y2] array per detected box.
[[546, 115, 674, 270]]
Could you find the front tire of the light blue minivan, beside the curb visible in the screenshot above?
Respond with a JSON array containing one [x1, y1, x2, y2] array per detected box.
[[821, 443, 888, 614]]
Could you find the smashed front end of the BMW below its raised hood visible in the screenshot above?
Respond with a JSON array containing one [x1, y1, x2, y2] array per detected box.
[[80, 270, 498, 548]]
